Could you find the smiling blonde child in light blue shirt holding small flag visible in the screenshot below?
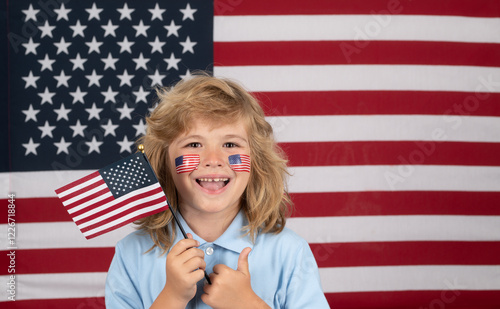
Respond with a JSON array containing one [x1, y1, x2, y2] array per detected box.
[[106, 75, 328, 309]]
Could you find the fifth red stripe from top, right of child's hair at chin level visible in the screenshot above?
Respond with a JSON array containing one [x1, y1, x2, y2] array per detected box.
[[291, 191, 500, 217]]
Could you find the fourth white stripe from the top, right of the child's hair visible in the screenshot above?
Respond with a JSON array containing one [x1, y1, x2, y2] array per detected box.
[[289, 165, 500, 193]]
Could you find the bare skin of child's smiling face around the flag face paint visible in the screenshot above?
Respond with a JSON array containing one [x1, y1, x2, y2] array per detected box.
[[169, 118, 250, 214]]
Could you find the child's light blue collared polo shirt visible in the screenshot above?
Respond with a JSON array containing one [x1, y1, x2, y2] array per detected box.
[[106, 211, 329, 309]]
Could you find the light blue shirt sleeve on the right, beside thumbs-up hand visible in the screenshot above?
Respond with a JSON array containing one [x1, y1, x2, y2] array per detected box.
[[285, 239, 330, 309]]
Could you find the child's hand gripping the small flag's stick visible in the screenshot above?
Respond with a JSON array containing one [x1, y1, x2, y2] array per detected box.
[[163, 234, 206, 307]]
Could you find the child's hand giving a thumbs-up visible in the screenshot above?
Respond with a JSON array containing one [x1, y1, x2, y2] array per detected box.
[[201, 248, 269, 309]]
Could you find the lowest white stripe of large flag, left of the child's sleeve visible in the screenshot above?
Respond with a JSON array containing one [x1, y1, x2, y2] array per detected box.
[[0, 272, 106, 301]]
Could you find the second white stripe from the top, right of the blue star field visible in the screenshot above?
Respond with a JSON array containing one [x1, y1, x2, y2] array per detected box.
[[214, 65, 500, 92]]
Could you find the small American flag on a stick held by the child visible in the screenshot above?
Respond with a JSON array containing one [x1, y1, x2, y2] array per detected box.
[[56, 153, 168, 239]]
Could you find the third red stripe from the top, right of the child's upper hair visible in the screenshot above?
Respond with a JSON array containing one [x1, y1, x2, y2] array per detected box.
[[255, 91, 500, 116]]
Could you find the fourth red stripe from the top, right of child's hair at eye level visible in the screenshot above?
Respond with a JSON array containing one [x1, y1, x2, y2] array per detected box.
[[280, 141, 500, 166]]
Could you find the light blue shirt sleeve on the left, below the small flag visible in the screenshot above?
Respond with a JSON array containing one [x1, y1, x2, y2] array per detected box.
[[105, 242, 144, 309]]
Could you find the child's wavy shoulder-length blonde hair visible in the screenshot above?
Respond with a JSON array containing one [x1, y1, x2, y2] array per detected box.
[[136, 74, 292, 253]]
